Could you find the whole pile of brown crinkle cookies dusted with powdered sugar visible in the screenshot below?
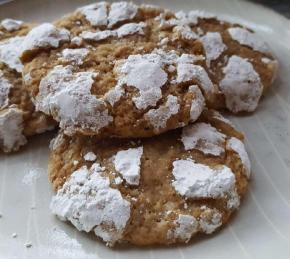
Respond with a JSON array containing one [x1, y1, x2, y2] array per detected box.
[[0, 2, 277, 249]]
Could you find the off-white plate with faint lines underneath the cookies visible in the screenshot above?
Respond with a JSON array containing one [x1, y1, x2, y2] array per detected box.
[[0, 0, 290, 259]]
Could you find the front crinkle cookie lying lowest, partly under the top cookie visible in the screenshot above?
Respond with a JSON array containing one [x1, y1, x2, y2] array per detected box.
[[49, 110, 251, 246]]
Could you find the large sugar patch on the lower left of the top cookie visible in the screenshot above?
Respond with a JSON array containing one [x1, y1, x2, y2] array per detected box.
[[36, 66, 113, 134]]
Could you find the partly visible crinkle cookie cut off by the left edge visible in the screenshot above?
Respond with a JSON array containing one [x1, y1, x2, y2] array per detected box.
[[0, 19, 54, 152]]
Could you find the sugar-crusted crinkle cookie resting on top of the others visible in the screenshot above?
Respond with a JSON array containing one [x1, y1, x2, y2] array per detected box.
[[22, 2, 219, 137]]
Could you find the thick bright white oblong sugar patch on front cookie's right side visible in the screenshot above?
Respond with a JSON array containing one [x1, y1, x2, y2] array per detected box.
[[172, 160, 235, 199]]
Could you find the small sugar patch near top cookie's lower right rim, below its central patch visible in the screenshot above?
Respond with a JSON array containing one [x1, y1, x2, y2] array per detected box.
[[144, 95, 180, 130]]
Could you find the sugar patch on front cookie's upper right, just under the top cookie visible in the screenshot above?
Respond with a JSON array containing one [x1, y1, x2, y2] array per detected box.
[[181, 122, 226, 156]]
